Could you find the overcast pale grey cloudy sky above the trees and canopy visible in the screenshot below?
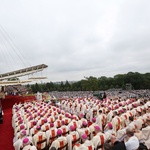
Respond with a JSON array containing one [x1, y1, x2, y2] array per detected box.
[[0, 0, 150, 82]]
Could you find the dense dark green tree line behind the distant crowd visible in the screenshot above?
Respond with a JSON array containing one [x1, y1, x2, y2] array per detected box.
[[27, 72, 150, 93]]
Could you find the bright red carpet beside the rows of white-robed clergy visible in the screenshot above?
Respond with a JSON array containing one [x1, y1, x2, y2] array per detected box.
[[0, 96, 35, 150]]
